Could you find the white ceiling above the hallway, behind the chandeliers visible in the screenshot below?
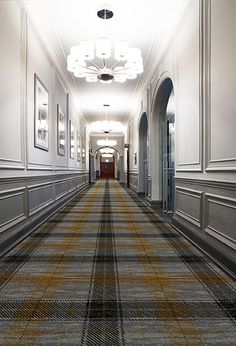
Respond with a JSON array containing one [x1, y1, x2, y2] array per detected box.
[[24, 0, 189, 127]]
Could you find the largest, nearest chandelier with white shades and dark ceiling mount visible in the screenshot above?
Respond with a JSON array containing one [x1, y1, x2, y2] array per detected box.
[[67, 9, 143, 83]]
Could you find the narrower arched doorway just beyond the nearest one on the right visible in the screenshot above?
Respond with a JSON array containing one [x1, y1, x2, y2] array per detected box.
[[139, 113, 148, 196]]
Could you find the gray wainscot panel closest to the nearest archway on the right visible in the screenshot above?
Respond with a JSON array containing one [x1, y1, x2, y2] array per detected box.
[[175, 186, 203, 229]]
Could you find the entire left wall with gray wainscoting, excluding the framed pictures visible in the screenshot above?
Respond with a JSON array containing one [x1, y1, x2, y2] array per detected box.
[[0, 0, 88, 251]]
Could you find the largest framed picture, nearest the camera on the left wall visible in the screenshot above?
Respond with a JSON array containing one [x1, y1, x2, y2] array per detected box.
[[34, 73, 49, 151]]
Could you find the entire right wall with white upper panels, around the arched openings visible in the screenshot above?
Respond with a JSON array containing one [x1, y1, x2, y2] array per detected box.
[[130, 0, 236, 270]]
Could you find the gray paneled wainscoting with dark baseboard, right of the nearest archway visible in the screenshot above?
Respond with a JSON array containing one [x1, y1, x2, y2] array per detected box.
[[173, 178, 236, 272]]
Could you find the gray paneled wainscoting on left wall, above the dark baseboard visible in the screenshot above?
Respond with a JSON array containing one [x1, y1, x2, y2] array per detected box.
[[0, 172, 88, 232]]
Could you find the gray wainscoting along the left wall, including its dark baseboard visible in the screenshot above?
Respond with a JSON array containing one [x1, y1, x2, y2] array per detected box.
[[0, 172, 89, 253]]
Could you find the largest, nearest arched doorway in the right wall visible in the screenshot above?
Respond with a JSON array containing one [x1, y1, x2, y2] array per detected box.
[[153, 78, 175, 214]]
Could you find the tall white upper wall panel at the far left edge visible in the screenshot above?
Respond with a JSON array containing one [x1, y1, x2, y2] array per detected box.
[[0, 1, 23, 166]]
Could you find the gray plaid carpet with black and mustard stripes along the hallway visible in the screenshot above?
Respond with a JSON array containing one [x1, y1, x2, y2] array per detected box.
[[0, 180, 236, 346]]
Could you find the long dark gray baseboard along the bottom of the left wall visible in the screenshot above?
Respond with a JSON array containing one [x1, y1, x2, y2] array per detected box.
[[0, 185, 89, 256]]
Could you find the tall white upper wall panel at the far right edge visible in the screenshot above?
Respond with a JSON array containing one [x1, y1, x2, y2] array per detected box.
[[209, 0, 236, 166]]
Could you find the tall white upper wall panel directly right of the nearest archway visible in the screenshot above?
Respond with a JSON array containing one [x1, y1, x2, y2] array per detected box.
[[176, 1, 200, 169]]
